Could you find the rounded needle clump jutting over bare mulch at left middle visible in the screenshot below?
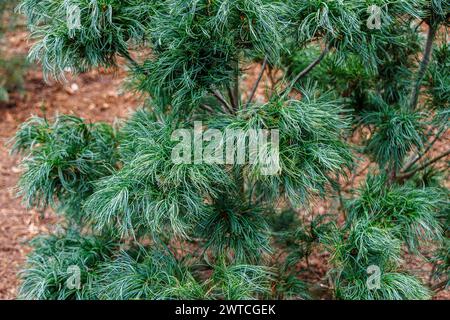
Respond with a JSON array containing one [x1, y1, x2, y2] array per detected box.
[[12, 115, 118, 219]]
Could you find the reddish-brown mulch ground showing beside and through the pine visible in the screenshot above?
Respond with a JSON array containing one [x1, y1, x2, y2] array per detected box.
[[0, 31, 450, 299]]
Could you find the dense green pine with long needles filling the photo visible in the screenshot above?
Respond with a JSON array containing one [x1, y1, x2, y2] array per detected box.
[[12, 0, 450, 299]]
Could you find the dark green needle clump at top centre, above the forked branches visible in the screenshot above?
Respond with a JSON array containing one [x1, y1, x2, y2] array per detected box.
[[135, 0, 285, 108]]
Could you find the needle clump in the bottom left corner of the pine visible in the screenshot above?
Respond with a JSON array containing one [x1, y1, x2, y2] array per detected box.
[[19, 230, 117, 300]]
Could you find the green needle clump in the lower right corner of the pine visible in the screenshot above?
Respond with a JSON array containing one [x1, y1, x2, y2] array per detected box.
[[324, 176, 445, 300]]
